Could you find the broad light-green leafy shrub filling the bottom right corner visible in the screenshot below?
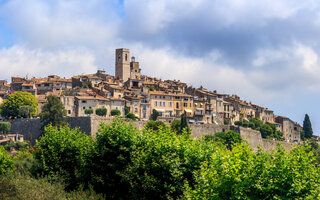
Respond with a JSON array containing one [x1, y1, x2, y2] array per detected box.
[[184, 145, 320, 200]]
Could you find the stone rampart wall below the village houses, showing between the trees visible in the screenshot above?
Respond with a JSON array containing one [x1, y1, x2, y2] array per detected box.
[[11, 116, 294, 152]]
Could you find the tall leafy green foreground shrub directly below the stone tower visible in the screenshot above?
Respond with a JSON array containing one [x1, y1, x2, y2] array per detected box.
[[86, 120, 137, 199]]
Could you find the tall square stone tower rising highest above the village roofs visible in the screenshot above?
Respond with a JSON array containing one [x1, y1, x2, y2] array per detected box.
[[115, 48, 130, 82]]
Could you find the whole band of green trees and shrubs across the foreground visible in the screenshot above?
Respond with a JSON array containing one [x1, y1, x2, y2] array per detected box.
[[0, 120, 320, 199]]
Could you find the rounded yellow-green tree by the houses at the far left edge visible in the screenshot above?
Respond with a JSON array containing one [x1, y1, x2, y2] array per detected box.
[[0, 91, 38, 118]]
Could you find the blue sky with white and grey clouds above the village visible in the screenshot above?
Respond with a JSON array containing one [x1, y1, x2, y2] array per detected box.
[[0, 0, 320, 135]]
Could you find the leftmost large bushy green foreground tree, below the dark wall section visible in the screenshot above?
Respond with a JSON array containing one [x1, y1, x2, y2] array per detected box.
[[34, 125, 93, 189]]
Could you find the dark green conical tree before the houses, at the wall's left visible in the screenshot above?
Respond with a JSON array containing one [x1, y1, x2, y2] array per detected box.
[[40, 95, 67, 130]]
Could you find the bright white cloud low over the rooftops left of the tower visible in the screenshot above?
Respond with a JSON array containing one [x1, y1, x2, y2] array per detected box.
[[0, 46, 97, 79]]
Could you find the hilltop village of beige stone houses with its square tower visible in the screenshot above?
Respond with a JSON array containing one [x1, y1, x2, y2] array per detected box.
[[0, 48, 302, 142]]
